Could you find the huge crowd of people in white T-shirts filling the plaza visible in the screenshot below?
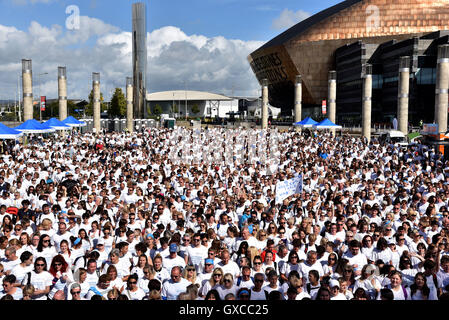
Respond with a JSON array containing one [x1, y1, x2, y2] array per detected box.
[[0, 128, 449, 300]]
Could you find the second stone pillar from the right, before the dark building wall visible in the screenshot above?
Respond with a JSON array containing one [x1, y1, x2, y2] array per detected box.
[[397, 56, 410, 136]]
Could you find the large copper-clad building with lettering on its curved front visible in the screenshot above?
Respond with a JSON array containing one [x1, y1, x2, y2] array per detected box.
[[248, 0, 449, 123]]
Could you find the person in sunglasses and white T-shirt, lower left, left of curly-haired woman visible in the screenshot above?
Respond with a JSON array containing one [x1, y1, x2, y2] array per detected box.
[[22, 257, 53, 300]]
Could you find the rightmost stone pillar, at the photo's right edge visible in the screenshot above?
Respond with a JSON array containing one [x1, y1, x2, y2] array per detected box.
[[435, 44, 449, 134]]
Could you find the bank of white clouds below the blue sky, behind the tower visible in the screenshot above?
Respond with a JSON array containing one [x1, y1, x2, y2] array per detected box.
[[0, 17, 263, 99]]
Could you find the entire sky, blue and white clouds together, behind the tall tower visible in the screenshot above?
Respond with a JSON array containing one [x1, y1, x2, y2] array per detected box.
[[0, 0, 340, 99]]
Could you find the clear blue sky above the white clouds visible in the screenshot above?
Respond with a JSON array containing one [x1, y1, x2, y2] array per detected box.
[[0, 0, 340, 41]]
